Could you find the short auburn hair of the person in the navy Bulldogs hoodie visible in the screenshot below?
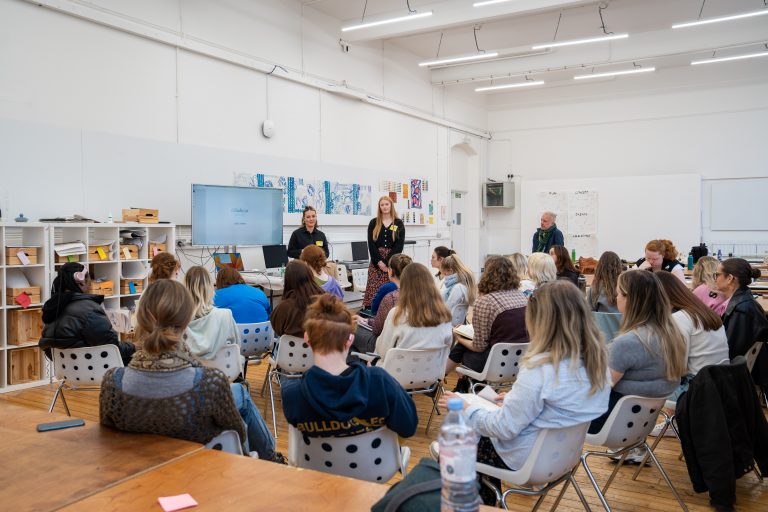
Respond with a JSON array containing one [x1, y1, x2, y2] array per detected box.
[[304, 293, 355, 354]]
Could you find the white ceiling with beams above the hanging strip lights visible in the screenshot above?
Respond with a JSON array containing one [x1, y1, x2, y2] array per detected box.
[[304, 0, 768, 92]]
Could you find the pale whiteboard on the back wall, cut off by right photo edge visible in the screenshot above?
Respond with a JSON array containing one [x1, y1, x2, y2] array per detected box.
[[709, 178, 768, 231]]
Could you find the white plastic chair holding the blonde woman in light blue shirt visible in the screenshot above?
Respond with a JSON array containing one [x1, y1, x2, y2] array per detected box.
[[477, 423, 590, 512]]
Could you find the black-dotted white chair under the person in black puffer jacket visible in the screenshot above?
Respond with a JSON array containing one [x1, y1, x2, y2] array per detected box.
[[48, 345, 123, 416]]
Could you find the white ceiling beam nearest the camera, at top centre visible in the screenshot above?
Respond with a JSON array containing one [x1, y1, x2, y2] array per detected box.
[[340, 0, 595, 42]]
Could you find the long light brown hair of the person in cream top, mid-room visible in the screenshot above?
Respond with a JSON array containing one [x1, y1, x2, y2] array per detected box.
[[392, 263, 452, 327]]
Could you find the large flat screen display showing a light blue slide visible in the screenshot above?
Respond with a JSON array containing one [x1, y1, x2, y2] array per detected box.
[[192, 184, 283, 246]]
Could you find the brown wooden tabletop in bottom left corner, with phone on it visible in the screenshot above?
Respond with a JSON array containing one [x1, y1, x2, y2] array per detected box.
[[0, 400, 202, 511]]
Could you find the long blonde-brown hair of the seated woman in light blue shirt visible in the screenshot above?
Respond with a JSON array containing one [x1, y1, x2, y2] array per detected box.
[[523, 281, 608, 394]]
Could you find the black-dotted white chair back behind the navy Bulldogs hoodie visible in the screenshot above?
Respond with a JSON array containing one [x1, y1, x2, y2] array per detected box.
[[288, 425, 411, 484]]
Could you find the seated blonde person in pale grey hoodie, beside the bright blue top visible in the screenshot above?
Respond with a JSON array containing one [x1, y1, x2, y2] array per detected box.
[[184, 266, 240, 359]]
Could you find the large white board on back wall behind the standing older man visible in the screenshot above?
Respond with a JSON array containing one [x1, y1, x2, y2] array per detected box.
[[520, 174, 701, 260]]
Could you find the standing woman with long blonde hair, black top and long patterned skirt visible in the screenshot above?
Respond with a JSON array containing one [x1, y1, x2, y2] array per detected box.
[[363, 196, 405, 308]]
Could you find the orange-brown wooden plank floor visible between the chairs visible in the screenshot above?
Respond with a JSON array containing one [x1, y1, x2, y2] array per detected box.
[[0, 364, 768, 512]]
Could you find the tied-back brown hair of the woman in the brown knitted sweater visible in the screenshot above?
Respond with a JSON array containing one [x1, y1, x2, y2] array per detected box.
[[136, 279, 195, 355]]
